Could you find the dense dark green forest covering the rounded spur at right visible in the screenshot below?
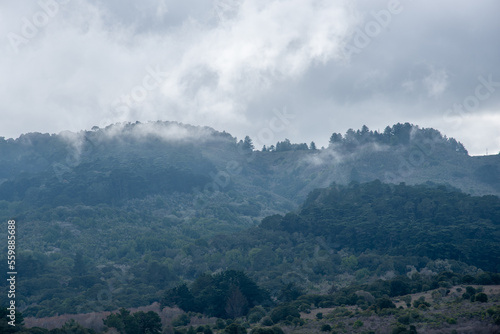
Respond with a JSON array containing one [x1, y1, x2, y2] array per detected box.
[[260, 181, 500, 271]]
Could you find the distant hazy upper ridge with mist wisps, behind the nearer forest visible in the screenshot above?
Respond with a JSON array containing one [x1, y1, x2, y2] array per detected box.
[[0, 122, 500, 209]]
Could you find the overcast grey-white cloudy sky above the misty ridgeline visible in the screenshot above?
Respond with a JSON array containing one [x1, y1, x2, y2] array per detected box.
[[0, 0, 500, 155]]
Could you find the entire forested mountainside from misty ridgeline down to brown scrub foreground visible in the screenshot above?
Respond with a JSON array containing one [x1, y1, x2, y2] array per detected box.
[[0, 122, 500, 330]]
